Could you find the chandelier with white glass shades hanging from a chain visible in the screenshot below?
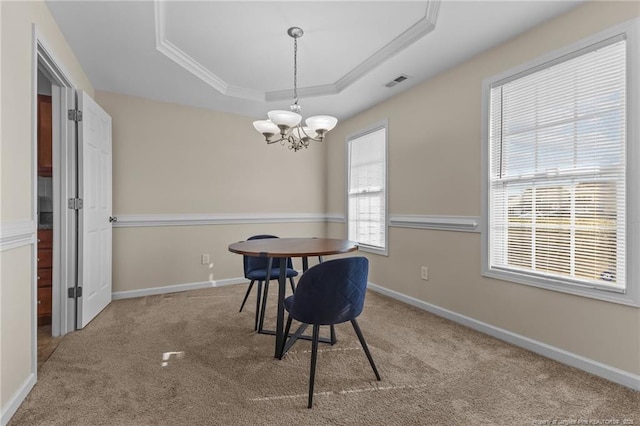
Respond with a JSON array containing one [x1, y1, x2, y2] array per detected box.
[[253, 27, 338, 151]]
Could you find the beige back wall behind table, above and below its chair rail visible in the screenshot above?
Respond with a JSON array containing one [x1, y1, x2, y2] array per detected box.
[[96, 91, 326, 291]]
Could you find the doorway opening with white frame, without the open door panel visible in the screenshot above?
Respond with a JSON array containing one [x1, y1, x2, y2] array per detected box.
[[32, 36, 77, 358]]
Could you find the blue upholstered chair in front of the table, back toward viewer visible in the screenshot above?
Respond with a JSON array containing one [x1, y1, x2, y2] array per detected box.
[[281, 257, 380, 408]]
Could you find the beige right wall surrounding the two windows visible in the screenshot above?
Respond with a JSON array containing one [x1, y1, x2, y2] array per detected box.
[[327, 2, 640, 375]]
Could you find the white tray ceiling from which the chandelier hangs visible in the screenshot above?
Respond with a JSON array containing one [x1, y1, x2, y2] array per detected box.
[[47, 0, 579, 119]]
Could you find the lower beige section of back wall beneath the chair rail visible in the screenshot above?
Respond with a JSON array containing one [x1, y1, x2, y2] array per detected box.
[[113, 223, 326, 292]]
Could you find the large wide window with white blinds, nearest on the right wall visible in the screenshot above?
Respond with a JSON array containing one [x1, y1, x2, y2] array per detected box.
[[483, 22, 640, 304]]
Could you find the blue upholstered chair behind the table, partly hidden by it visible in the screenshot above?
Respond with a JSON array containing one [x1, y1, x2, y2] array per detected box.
[[240, 235, 298, 330]]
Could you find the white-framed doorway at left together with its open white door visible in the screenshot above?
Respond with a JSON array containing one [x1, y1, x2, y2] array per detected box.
[[31, 32, 115, 372]]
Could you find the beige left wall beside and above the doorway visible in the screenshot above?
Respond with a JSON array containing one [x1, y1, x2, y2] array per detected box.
[[0, 1, 93, 413]]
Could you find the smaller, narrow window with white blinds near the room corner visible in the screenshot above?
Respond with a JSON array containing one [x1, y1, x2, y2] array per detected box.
[[347, 122, 387, 254]]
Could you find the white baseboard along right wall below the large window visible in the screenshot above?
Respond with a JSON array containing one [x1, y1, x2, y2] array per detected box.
[[368, 283, 640, 391]]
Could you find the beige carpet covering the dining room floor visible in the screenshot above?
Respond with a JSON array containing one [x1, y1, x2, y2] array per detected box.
[[10, 285, 640, 426]]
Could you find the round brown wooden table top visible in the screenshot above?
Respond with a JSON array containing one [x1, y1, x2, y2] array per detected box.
[[229, 238, 358, 257]]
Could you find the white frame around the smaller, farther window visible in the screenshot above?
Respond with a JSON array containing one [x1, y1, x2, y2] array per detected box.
[[344, 120, 389, 256]]
